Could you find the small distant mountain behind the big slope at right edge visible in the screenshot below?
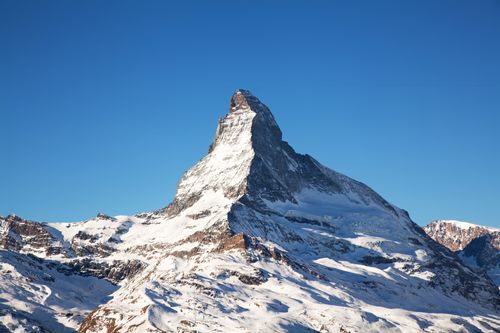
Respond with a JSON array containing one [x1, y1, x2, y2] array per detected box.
[[424, 220, 500, 288]]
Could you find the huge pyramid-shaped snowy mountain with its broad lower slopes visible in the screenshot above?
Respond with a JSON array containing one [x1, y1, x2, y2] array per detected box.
[[0, 90, 500, 333]]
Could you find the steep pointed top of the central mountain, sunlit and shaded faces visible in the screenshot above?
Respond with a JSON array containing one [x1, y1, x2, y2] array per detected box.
[[161, 89, 398, 216]]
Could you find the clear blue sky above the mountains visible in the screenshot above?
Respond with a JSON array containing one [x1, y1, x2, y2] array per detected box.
[[0, 0, 500, 226]]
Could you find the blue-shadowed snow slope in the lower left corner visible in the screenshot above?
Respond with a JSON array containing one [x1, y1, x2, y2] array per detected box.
[[0, 250, 117, 332]]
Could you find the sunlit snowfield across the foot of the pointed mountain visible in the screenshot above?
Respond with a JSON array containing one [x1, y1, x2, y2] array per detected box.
[[81, 249, 500, 332]]
